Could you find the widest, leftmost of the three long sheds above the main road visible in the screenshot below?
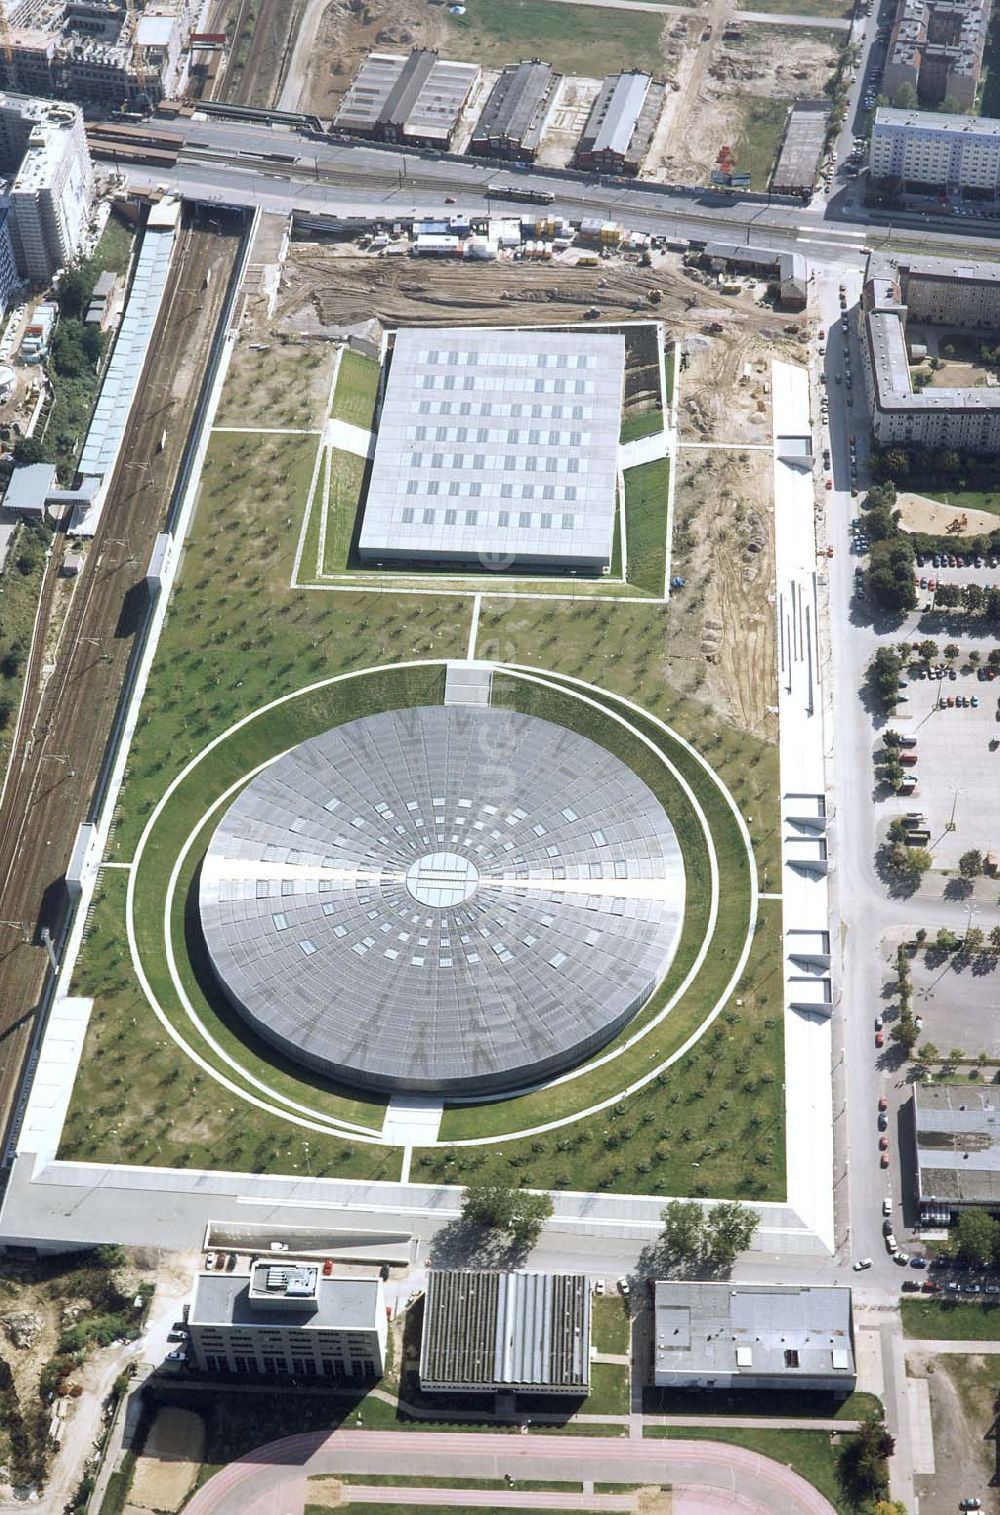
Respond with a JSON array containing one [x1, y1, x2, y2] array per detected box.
[[333, 48, 479, 150]]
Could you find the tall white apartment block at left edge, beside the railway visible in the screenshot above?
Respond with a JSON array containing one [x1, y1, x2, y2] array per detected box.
[[0, 94, 94, 283]]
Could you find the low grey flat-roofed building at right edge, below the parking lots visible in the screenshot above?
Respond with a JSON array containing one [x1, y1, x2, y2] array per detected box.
[[914, 1083, 1000, 1224]]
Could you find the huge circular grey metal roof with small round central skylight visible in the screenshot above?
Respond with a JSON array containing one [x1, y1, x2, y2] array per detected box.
[[200, 706, 685, 1095]]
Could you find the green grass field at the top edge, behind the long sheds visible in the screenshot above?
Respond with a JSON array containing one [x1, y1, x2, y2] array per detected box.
[[442, 0, 664, 79]]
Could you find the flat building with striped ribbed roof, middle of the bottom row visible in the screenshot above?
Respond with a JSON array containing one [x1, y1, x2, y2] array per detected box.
[[420, 1268, 591, 1397]]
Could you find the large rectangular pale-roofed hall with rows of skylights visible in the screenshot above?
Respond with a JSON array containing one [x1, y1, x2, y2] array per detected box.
[[359, 327, 624, 573]]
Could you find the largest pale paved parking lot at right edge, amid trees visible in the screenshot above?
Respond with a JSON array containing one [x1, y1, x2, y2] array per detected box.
[[885, 667, 1000, 870]]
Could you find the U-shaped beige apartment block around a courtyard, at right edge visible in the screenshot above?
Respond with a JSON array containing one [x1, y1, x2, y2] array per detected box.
[[861, 253, 1000, 453]]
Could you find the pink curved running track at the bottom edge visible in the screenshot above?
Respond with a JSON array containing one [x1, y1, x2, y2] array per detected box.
[[186, 1430, 832, 1515]]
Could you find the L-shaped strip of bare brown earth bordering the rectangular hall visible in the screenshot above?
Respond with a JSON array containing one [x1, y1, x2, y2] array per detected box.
[[259, 228, 793, 739]]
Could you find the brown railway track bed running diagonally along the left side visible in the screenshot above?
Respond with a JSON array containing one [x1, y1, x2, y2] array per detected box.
[[0, 212, 241, 1157]]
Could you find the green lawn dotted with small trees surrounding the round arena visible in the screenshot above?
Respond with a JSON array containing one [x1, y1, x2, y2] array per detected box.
[[61, 304, 785, 1205]]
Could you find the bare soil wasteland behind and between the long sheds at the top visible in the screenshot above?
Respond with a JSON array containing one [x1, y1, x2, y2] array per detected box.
[[277, 0, 847, 189]]
